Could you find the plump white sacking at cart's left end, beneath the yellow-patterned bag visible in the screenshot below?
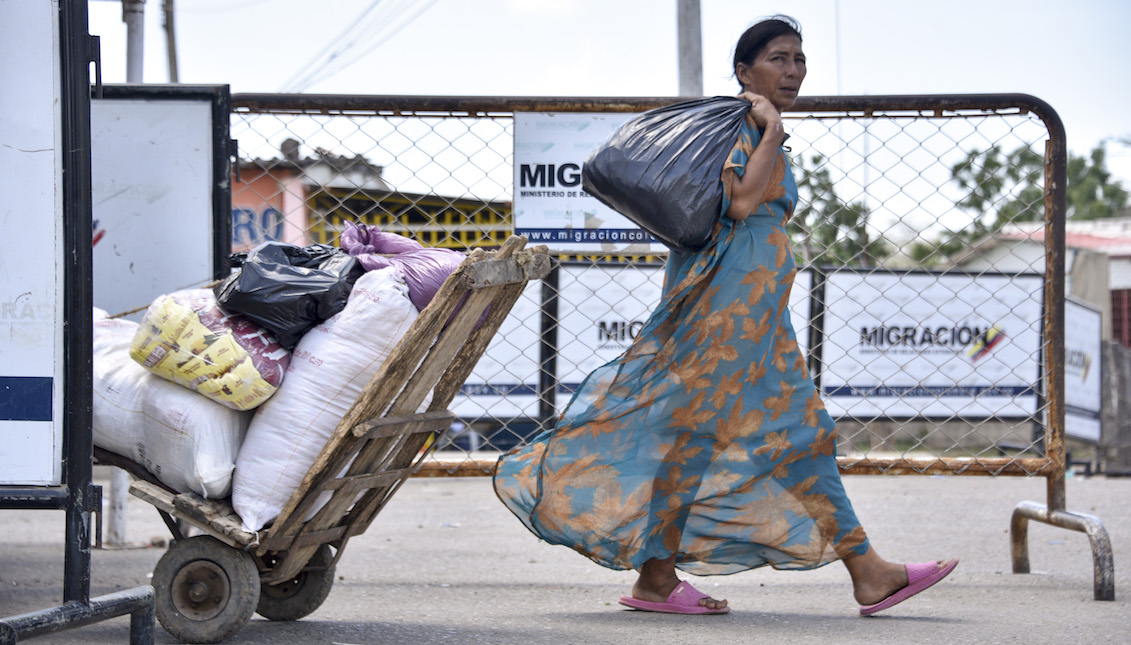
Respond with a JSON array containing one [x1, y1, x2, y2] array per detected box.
[[93, 310, 251, 498]]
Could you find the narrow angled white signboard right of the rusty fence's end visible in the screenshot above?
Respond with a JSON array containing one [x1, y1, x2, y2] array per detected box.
[[1064, 299, 1103, 442]]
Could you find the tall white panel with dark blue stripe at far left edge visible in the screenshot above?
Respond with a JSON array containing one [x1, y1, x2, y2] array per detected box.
[[0, 0, 63, 485]]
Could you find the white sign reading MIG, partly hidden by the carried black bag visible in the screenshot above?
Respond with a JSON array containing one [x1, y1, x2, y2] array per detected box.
[[513, 112, 663, 253]]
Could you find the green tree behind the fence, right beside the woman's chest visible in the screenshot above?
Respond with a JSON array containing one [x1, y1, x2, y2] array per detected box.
[[788, 154, 891, 267]]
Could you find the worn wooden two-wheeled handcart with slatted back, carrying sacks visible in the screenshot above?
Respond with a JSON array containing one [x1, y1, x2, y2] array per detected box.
[[95, 237, 550, 643]]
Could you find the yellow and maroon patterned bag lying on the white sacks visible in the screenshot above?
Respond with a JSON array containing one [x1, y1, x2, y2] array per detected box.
[[130, 289, 291, 410]]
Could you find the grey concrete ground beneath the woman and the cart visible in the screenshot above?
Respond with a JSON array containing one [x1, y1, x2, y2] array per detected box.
[[0, 471, 1131, 645]]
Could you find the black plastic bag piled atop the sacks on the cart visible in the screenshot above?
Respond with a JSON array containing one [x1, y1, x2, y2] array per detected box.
[[214, 242, 365, 350]]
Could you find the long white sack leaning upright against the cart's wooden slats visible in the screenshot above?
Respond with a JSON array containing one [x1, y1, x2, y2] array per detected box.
[[232, 267, 428, 531]]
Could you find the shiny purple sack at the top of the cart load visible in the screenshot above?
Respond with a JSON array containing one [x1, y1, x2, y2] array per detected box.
[[340, 222, 465, 311]]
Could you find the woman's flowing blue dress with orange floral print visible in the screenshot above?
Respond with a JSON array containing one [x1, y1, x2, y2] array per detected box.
[[494, 124, 867, 575]]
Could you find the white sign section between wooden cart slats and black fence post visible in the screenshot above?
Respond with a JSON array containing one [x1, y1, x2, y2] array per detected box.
[[449, 281, 542, 421]]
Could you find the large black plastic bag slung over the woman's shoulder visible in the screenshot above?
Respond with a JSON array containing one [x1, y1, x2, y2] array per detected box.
[[581, 96, 750, 250]]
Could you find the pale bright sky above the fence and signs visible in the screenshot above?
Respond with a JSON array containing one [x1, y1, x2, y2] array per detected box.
[[89, 0, 1131, 187]]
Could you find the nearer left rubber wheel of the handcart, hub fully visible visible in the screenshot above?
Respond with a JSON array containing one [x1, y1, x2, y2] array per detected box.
[[153, 535, 259, 643]]
